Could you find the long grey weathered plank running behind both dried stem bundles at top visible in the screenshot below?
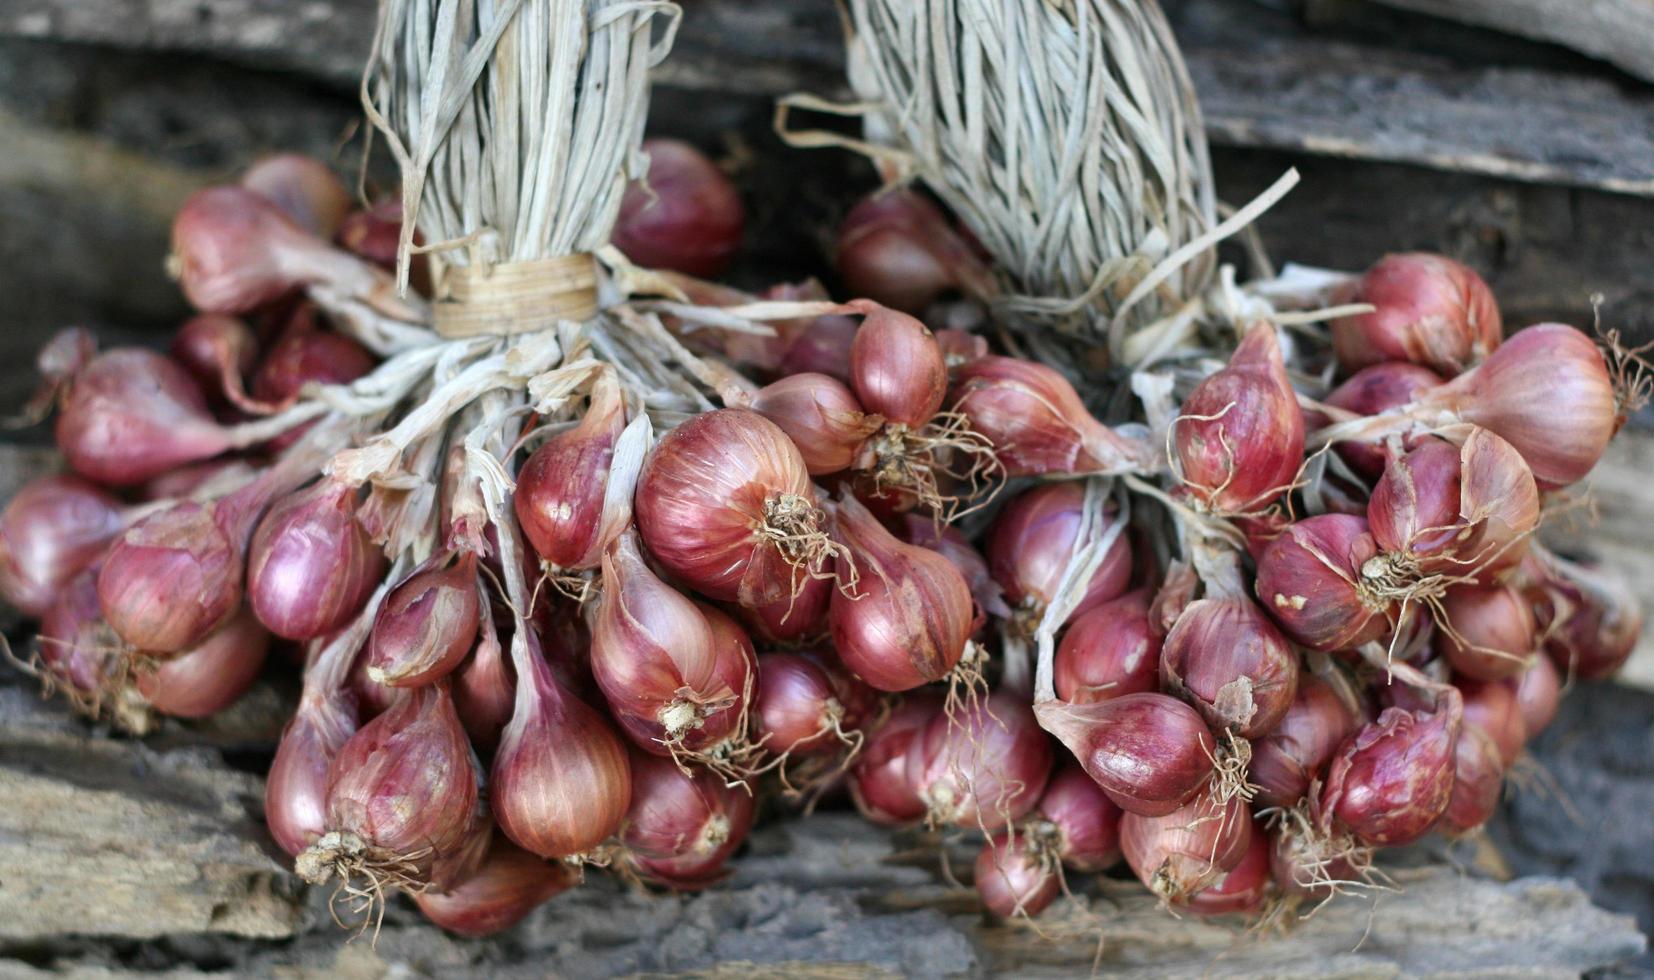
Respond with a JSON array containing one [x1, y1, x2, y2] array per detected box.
[[0, 0, 1654, 195]]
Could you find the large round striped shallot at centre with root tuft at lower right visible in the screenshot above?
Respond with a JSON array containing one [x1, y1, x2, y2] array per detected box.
[[633, 408, 830, 607]]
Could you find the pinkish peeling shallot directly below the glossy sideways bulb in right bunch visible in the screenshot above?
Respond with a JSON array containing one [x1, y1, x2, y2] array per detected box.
[[1120, 790, 1252, 906]]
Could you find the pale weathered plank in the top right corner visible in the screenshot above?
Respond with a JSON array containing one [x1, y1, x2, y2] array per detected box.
[[1378, 0, 1654, 81]]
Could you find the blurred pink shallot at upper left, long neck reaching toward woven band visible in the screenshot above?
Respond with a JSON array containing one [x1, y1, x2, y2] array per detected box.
[[169, 187, 412, 314]]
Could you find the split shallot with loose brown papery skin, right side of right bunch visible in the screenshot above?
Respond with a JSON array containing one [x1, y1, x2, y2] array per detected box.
[[1366, 428, 1540, 575]]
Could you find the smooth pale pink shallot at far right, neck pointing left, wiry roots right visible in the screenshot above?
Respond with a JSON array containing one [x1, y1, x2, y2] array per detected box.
[[1413, 324, 1619, 489]]
